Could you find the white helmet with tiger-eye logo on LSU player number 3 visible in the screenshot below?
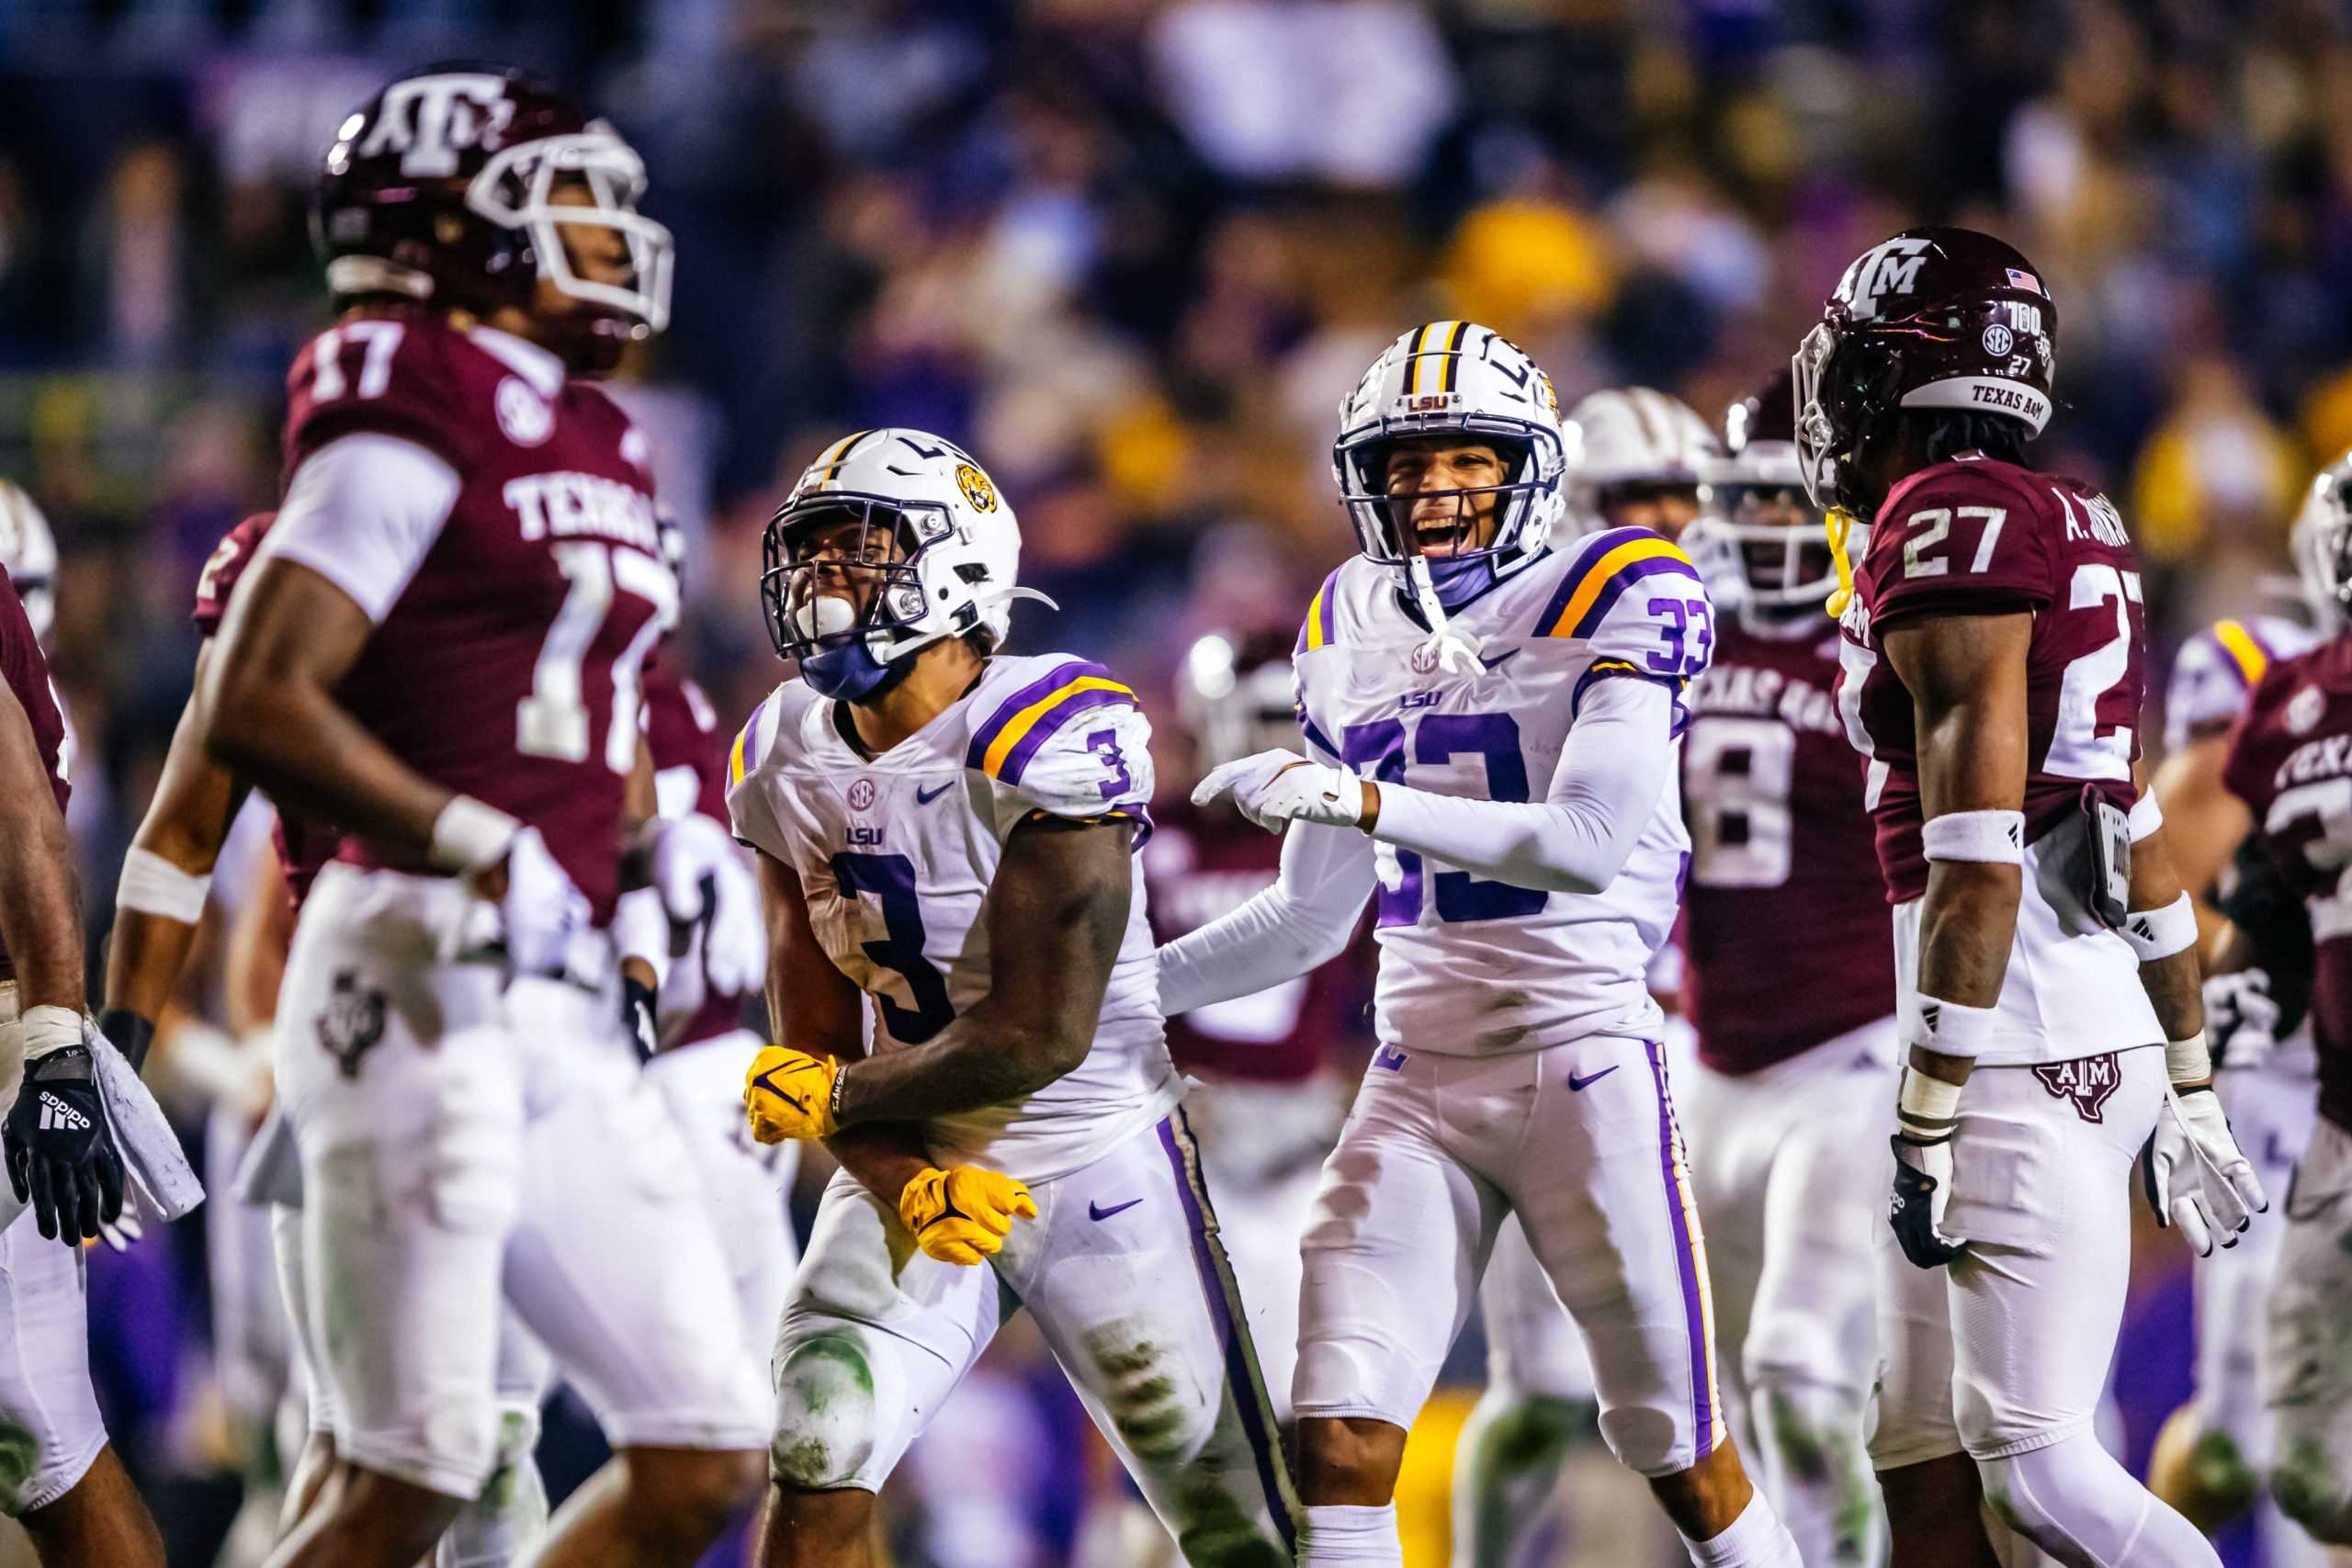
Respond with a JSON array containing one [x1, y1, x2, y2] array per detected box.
[[760, 430, 1051, 701]]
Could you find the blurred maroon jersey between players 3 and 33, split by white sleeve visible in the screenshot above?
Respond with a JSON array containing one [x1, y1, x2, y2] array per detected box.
[[1143, 797, 1371, 1084]]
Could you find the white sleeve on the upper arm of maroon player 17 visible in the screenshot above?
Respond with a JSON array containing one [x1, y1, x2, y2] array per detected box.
[[256, 433, 461, 621]]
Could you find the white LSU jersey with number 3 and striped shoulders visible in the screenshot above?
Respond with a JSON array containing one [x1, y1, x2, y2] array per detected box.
[[727, 653, 1183, 1182]]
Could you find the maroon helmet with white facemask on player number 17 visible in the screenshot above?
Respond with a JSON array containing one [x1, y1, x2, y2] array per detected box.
[[311, 66, 671, 371]]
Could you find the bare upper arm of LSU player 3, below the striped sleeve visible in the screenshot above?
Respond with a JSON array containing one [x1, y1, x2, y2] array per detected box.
[[988, 816, 1136, 1058]]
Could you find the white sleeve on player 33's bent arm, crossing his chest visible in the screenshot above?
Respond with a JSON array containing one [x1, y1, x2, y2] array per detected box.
[[1371, 680, 1675, 894]]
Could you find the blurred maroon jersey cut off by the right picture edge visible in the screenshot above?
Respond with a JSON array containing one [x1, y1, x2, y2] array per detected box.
[[2221, 637, 2352, 1131]]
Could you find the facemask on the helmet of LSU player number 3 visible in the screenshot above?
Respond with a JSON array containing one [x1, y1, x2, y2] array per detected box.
[[760, 491, 955, 701]]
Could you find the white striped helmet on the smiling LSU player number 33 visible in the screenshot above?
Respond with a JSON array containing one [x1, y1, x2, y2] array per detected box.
[[1331, 322, 1566, 604]]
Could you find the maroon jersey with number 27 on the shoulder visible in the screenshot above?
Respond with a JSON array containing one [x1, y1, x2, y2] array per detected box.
[[1837, 456, 2147, 903]]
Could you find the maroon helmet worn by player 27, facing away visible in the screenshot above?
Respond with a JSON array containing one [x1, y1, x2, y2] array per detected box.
[[1792, 228, 2058, 522]]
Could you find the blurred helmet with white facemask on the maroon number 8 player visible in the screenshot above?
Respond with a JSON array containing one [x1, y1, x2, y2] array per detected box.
[[1681, 369, 1837, 614]]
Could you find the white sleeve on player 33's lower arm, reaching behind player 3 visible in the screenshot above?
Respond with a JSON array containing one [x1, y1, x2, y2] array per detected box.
[[1159, 823, 1374, 1018]]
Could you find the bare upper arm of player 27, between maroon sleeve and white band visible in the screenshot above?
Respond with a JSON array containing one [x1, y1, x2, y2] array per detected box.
[[1879, 611, 2034, 816]]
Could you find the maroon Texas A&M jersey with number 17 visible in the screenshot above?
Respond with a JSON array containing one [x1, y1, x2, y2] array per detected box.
[[285, 310, 675, 924]]
